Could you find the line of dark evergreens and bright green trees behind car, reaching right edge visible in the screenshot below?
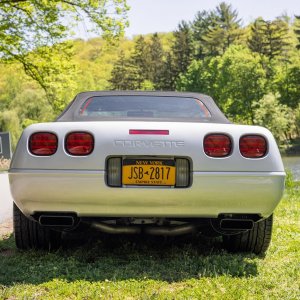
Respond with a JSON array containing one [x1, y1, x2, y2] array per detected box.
[[109, 2, 300, 141]]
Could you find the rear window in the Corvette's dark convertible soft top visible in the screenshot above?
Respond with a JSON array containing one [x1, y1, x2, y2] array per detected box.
[[79, 96, 211, 120]]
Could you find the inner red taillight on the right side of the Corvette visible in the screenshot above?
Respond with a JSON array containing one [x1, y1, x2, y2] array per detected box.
[[203, 134, 231, 157]]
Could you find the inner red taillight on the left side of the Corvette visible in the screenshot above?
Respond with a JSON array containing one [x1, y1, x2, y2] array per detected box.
[[65, 132, 94, 156]]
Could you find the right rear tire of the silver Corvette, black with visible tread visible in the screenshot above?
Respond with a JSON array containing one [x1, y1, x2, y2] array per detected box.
[[223, 215, 273, 255]]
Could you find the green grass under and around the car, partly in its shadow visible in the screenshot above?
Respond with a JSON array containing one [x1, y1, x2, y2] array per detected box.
[[0, 190, 300, 300]]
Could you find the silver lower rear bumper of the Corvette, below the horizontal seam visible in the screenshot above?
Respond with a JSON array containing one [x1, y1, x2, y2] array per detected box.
[[9, 169, 285, 218]]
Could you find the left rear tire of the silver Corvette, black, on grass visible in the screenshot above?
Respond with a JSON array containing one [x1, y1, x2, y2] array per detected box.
[[13, 203, 61, 251]]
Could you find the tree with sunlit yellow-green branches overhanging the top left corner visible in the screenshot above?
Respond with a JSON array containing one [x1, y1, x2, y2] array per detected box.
[[0, 0, 128, 110]]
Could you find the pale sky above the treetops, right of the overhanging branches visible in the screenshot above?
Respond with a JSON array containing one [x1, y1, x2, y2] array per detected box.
[[126, 0, 300, 38]]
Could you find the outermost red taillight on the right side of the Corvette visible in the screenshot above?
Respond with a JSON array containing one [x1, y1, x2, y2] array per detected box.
[[240, 135, 267, 158]]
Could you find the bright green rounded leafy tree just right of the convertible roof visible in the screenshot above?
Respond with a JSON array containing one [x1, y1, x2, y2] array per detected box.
[[216, 45, 266, 124]]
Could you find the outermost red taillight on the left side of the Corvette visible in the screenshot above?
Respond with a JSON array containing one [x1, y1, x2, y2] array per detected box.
[[28, 132, 58, 156]]
